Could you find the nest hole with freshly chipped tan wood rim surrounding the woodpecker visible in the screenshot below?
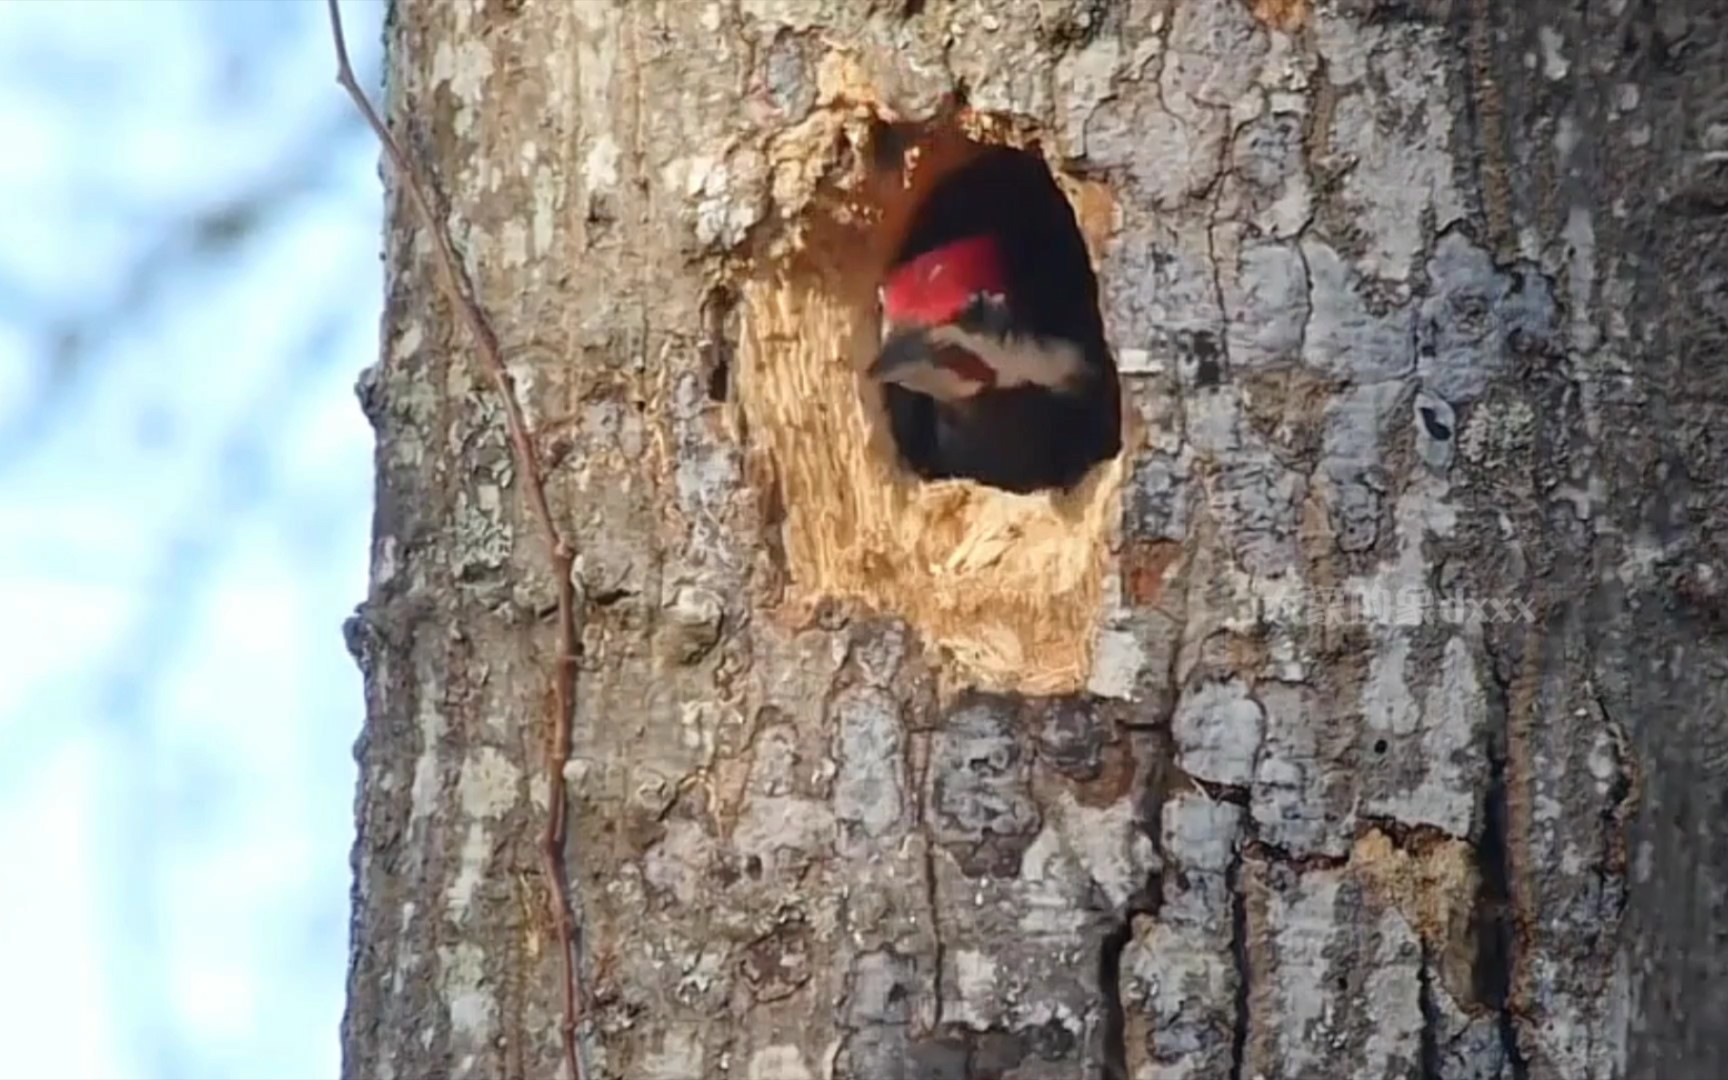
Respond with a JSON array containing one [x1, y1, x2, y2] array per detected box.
[[733, 121, 1127, 695]]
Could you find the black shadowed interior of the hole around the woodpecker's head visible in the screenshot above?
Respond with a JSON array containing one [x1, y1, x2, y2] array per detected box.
[[883, 147, 1121, 492]]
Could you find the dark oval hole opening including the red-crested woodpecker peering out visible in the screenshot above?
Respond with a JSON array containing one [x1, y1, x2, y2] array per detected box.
[[867, 150, 1121, 492]]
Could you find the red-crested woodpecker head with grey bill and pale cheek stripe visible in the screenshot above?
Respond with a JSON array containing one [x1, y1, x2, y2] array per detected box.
[[869, 235, 1085, 401]]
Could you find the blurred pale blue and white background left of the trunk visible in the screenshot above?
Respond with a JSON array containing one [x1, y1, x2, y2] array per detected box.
[[0, 0, 382, 1080]]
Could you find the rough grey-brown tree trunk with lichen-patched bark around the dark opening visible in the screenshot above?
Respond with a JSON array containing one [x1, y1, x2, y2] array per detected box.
[[342, 0, 1728, 1080]]
